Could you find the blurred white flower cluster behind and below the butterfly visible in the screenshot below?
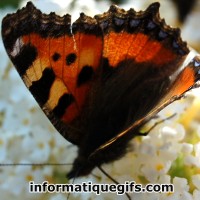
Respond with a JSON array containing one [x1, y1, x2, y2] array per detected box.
[[0, 0, 200, 200]]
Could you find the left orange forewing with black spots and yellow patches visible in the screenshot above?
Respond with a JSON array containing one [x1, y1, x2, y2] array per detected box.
[[2, 3, 103, 144]]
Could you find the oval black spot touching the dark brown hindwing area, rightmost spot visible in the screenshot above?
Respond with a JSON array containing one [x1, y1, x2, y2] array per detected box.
[[77, 65, 94, 87]]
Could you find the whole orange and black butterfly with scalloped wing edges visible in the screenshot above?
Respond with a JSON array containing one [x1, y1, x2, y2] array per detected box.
[[2, 2, 200, 178]]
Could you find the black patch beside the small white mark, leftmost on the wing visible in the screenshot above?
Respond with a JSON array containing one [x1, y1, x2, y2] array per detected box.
[[12, 44, 38, 76]]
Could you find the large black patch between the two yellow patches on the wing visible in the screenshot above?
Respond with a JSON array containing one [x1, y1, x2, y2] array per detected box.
[[29, 68, 55, 106]]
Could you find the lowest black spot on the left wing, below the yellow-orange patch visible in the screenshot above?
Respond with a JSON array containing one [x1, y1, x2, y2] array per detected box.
[[53, 94, 74, 118]]
